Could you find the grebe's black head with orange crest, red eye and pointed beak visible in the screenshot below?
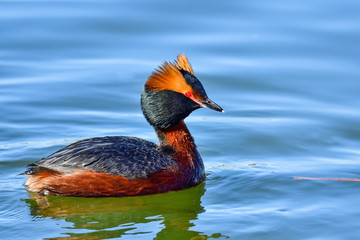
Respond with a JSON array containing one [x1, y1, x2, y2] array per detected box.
[[141, 55, 223, 129]]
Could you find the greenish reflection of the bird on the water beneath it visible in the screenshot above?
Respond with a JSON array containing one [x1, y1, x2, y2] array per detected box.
[[25, 184, 227, 239]]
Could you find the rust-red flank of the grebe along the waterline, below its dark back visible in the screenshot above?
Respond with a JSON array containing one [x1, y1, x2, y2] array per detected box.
[[25, 167, 191, 197]]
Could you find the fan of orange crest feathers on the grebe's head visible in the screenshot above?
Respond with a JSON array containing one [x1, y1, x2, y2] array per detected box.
[[145, 54, 194, 93]]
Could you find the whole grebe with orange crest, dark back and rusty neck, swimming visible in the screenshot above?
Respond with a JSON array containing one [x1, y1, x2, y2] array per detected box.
[[25, 55, 222, 197]]
